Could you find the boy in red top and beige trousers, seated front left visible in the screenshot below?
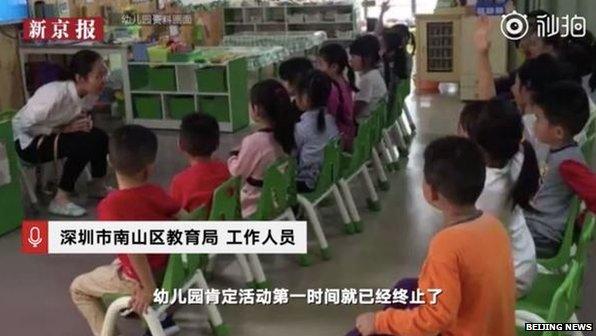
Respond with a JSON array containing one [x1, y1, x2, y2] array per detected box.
[[70, 125, 180, 336]]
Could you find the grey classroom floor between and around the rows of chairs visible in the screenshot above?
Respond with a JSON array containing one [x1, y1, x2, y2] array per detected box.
[[0, 89, 596, 336]]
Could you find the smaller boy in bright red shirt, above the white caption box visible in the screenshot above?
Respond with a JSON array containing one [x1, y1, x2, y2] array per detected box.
[[170, 113, 230, 211]]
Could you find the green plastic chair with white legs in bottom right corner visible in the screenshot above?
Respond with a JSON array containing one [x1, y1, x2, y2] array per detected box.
[[515, 261, 582, 336]]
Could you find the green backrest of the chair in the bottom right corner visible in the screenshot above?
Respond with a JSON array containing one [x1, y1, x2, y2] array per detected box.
[[544, 261, 581, 336]]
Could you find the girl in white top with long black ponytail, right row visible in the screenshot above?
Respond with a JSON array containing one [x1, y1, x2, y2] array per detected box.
[[459, 99, 539, 297]]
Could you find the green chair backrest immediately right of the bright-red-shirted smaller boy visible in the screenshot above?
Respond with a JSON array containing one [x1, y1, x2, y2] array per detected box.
[[209, 177, 242, 220]]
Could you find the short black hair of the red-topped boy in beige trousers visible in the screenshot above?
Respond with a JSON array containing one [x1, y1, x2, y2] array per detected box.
[[109, 125, 157, 176]]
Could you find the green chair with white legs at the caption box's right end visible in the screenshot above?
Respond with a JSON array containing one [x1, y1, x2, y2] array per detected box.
[[297, 139, 356, 260]]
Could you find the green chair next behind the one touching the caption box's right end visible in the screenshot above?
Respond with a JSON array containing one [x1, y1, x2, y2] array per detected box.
[[339, 118, 381, 213]]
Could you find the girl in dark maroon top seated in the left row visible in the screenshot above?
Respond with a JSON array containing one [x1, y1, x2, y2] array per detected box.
[[317, 43, 358, 150]]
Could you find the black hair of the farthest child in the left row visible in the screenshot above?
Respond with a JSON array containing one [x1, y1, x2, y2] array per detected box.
[[383, 24, 416, 84]]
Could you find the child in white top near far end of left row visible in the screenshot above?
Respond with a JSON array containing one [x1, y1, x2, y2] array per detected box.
[[350, 35, 387, 121]]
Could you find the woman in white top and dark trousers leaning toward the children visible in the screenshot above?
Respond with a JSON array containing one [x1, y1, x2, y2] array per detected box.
[[12, 50, 108, 217]]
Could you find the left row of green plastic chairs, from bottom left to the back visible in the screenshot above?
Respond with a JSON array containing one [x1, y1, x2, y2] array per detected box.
[[102, 81, 414, 336]]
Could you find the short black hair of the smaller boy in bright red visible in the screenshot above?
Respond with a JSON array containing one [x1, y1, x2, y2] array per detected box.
[[180, 113, 219, 157]]
